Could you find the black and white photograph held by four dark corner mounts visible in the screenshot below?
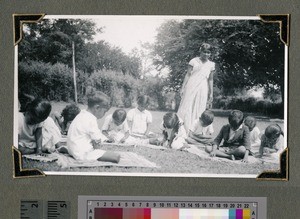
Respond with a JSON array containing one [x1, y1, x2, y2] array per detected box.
[[14, 15, 288, 178]]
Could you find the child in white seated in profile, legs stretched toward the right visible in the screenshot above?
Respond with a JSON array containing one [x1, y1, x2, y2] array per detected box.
[[67, 92, 120, 163]]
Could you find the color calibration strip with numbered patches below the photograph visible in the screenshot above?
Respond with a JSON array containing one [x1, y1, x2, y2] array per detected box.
[[78, 196, 267, 219]]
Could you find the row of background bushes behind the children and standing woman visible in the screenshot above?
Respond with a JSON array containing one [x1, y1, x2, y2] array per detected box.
[[18, 61, 284, 118]]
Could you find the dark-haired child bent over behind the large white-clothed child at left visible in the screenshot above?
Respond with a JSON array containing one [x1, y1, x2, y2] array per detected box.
[[51, 104, 80, 135]]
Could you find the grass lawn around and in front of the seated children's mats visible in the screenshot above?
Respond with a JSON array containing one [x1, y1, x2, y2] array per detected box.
[[23, 102, 283, 175]]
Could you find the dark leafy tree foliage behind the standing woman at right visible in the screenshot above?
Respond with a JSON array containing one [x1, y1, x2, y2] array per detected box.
[[153, 20, 284, 100]]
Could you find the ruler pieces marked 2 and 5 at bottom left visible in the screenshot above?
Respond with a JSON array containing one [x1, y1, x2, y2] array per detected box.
[[20, 200, 70, 219]]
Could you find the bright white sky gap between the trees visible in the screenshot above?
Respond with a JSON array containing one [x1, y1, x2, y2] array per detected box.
[[93, 16, 166, 54]]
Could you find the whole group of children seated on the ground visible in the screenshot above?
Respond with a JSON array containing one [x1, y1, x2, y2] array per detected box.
[[18, 92, 283, 163]]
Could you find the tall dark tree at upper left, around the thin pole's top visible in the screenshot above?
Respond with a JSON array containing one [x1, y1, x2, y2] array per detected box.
[[19, 19, 101, 66]]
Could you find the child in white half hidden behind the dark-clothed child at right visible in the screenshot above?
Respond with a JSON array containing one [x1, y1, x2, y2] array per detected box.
[[244, 116, 260, 153]]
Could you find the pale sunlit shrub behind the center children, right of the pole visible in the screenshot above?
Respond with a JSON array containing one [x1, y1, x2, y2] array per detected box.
[[88, 71, 172, 110]]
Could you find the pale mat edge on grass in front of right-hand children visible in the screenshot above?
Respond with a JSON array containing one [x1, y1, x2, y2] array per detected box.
[[185, 144, 262, 164]]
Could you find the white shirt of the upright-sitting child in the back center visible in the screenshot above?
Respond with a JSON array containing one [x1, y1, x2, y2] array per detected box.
[[127, 108, 152, 135]]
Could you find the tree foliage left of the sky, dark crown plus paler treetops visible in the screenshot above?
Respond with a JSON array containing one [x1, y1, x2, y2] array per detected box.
[[19, 19, 141, 77]]
